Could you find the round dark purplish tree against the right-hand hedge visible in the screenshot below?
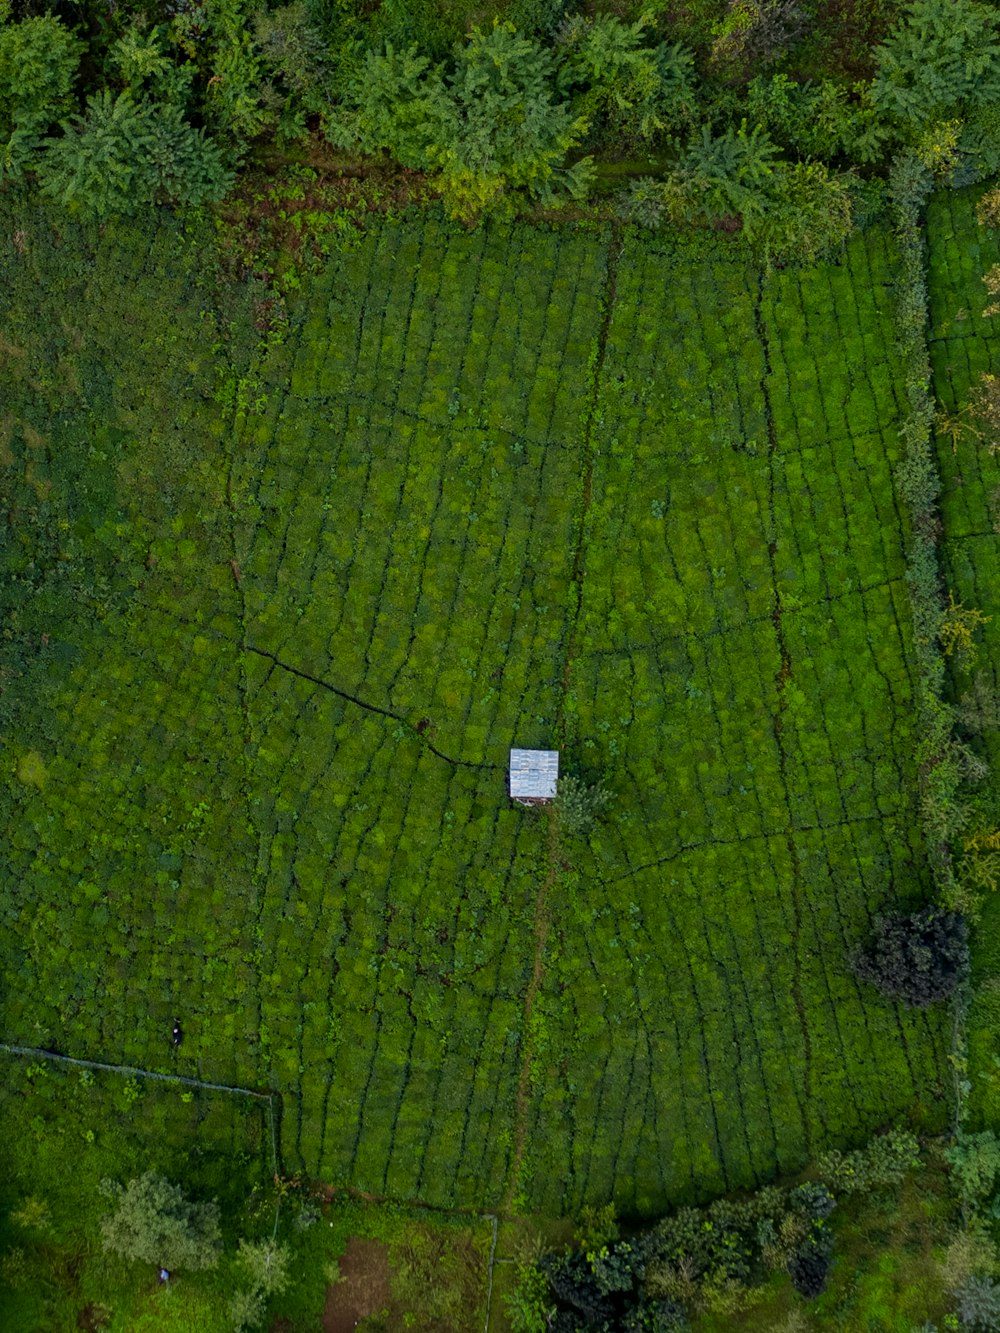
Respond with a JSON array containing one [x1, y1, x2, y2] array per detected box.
[[853, 908, 968, 1009]]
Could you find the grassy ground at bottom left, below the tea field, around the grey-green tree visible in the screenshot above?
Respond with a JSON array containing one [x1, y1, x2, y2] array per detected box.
[[0, 1056, 491, 1333]]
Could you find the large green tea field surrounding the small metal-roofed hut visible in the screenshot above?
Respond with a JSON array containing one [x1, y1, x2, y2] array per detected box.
[[0, 200, 949, 1213]]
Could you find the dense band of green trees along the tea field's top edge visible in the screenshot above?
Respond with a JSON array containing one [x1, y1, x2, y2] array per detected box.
[[0, 0, 1000, 250]]
